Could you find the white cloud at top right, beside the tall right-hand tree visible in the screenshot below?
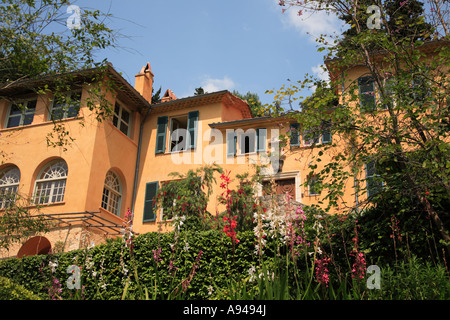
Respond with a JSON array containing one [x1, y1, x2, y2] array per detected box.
[[280, 2, 344, 43]]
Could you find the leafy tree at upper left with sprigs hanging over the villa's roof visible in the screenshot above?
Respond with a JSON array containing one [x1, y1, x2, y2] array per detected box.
[[0, 0, 118, 146]]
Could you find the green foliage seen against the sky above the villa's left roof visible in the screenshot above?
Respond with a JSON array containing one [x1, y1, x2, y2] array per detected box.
[[0, 0, 115, 84]]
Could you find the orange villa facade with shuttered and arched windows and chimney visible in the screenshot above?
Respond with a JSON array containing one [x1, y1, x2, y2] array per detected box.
[[0, 40, 446, 258]]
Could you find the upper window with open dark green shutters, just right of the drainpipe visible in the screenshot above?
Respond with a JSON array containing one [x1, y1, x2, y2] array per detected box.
[[155, 111, 199, 154]]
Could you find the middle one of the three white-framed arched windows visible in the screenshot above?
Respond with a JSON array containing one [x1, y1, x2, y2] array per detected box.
[[34, 160, 68, 204]]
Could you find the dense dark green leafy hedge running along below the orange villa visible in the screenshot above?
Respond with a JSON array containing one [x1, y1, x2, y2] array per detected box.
[[0, 230, 273, 299]]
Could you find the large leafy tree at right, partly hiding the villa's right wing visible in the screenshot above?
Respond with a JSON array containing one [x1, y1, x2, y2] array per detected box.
[[272, 0, 450, 254]]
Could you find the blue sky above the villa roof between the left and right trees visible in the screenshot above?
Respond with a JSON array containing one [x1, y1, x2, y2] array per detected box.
[[75, 0, 339, 103]]
